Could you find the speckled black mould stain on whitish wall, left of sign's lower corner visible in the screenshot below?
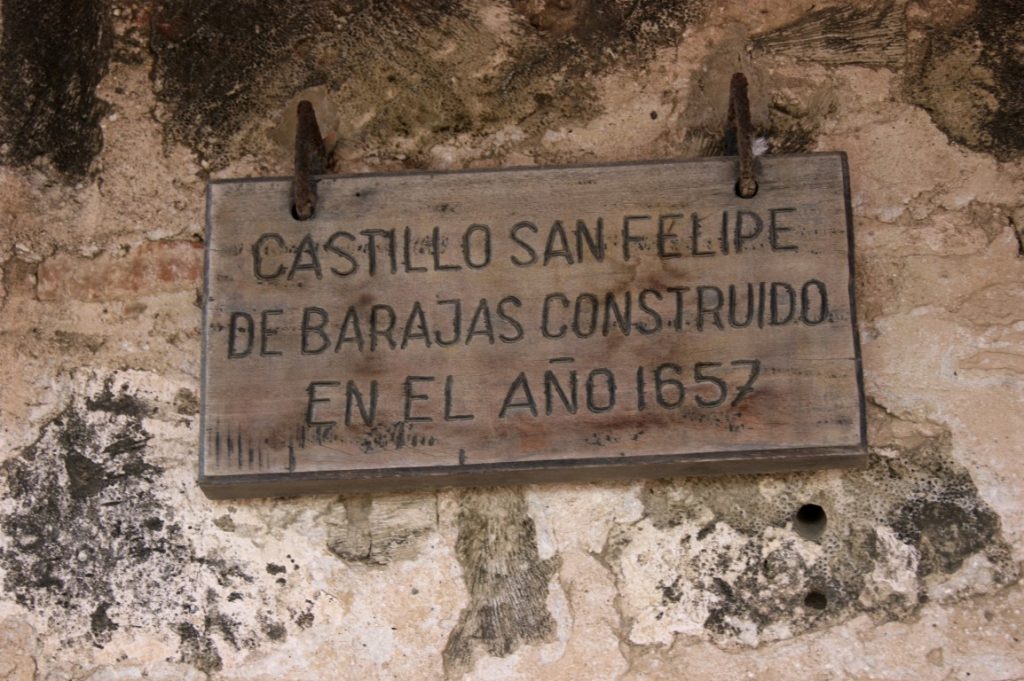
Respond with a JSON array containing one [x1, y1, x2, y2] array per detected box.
[[0, 387, 167, 644]]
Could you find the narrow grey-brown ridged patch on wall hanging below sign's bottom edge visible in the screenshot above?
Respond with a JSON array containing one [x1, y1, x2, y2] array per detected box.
[[443, 488, 561, 677]]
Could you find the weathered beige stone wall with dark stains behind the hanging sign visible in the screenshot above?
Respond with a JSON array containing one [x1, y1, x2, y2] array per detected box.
[[0, 0, 1024, 681]]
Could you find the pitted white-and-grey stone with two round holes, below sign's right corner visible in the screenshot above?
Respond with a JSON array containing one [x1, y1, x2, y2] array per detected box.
[[605, 415, 1019, 647]]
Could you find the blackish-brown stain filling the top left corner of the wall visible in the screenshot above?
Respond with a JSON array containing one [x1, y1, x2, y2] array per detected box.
[[0, 0, 112, 180]]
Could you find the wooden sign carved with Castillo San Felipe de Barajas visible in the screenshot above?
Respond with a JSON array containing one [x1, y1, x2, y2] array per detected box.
[[200, 154, 865, 498]]
